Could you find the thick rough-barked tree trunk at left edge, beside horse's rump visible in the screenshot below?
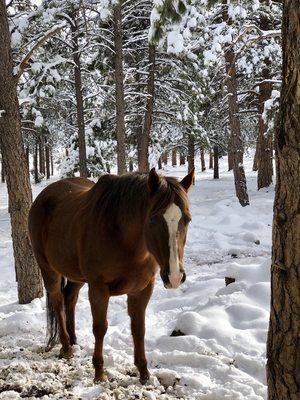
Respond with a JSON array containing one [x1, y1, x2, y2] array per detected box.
[[0, 0, 43, 304]]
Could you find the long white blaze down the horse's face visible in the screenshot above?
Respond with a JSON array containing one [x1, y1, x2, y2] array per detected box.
[[163, 203, 183, 288]]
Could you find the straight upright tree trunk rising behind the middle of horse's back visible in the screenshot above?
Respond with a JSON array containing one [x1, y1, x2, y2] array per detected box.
[[114, 0, 126, 175]]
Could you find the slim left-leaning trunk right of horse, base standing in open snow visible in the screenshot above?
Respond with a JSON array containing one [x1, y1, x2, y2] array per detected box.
[[223, 0, 249, 207]]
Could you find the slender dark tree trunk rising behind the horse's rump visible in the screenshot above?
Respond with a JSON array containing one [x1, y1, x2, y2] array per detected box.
[[71, 18, 88, 178]]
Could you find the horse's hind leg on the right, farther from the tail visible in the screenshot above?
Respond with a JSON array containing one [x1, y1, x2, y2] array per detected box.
[[64, 280, 84, 346]]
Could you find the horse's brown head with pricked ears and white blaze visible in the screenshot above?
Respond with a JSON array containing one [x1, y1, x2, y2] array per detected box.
[[145, 168, 194, 288]]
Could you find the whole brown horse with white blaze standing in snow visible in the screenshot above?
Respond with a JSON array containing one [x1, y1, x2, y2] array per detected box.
[[29, 169, 194, 383]]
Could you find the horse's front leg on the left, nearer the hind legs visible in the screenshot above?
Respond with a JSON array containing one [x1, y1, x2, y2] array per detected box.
[[89, 281, 109, 383]]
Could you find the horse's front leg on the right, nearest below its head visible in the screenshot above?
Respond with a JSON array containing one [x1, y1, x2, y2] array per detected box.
[[128, 279, 154, 384]]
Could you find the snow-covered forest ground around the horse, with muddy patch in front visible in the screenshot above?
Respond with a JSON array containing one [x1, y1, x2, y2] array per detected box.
[[0, 157, 274, 400]]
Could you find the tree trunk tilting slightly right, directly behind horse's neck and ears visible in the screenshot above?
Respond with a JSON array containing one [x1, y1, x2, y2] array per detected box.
[[139, 44, 155, 172]]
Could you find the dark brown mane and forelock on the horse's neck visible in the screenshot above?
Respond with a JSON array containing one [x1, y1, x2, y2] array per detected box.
[[89, 173, 189, 223]]
